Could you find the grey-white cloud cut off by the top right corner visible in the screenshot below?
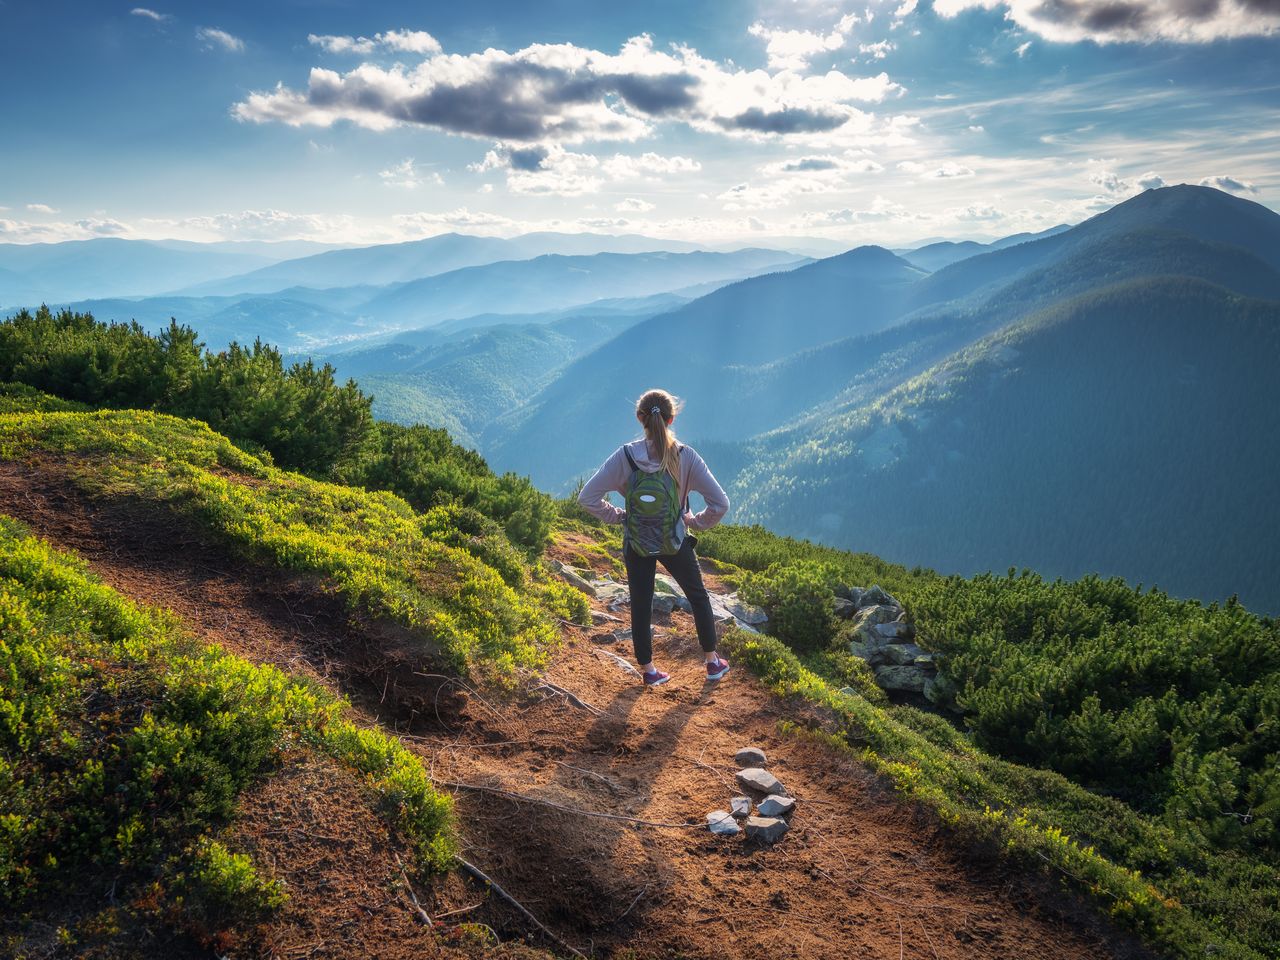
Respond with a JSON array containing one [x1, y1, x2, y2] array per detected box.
[[933, 0, 1280, 44]]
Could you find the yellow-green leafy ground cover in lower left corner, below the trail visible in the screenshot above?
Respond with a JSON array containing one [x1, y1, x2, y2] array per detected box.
[[0, 516, 456, 950]]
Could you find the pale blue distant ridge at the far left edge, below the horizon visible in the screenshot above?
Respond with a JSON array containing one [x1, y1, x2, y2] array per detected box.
[[0, 237, 300, 307]]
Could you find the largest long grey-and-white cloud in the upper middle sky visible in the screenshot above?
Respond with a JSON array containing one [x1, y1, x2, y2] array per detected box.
[[233, 36, 902, 143]]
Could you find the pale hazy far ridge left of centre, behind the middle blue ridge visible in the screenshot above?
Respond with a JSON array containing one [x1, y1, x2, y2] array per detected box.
[[172, 233, 699, 296]]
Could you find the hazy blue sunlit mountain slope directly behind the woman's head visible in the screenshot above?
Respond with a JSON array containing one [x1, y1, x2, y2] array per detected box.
[[481, 247, 922, 486]]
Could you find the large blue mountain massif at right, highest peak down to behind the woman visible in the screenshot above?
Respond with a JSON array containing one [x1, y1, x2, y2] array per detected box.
[[407, 186, 1280, 612]]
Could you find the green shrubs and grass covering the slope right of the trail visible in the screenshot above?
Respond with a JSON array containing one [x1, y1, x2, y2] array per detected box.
[[699, 527, 1280, 957]]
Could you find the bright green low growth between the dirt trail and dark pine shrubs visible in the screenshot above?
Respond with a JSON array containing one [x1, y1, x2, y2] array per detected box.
[[0, 411, 586, 680]]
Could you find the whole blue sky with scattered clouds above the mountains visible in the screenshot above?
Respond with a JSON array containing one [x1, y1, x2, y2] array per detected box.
[[0, 0, 1280, 246]]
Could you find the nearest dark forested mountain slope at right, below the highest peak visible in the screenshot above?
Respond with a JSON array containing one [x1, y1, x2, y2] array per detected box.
[[736, 276, 1280, 612]]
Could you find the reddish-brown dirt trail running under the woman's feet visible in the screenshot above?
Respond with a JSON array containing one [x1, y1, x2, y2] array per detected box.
[[0, 463, 1147, 960]]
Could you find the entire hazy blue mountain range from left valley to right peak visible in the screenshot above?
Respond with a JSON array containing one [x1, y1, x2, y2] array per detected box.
[[0, 186, 1280, 612]]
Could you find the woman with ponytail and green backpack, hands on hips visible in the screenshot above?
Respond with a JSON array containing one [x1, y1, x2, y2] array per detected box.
[[577, 390, 728, 686]]
